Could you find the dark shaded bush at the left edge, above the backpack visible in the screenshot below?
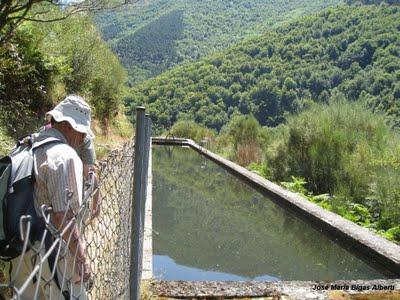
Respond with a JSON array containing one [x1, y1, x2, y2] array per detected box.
[[0, 28, 52, 138]]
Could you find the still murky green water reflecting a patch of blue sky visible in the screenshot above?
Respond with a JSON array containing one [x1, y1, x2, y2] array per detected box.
[[153, 146, 384, 281]]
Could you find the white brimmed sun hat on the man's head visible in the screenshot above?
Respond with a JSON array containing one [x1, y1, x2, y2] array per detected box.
[[46, 95, 94, 137]]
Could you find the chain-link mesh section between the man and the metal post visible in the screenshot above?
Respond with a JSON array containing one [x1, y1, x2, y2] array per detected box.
[[84, 142, 134, 299]]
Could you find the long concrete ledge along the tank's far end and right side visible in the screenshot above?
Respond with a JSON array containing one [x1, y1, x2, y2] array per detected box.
[[152, 138, 400, 278]]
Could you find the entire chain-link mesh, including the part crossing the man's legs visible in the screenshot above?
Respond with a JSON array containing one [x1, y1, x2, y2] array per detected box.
[[0, 141, 134, 299]]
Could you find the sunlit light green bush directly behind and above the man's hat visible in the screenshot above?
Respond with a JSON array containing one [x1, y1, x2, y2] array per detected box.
[[36, 11, 126, 126]]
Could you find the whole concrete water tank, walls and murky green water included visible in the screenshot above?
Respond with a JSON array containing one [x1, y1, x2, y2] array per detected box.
[[143, 138, 400, 299]]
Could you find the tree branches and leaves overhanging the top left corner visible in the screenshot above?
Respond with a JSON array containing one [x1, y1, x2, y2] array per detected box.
[[0, 0, 136, 43]]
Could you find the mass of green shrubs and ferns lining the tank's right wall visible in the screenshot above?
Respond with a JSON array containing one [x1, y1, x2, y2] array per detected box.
[[216, 98, 400, 242]]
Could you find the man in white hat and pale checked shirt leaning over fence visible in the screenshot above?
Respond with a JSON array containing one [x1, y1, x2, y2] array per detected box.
[[12, 95, 93, 299]]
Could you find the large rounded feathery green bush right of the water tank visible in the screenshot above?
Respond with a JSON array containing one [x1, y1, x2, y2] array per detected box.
[[270, 100, 393, 199]]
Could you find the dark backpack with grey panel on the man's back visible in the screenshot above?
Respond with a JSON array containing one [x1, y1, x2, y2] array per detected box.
[[0, 136, 61, 260]]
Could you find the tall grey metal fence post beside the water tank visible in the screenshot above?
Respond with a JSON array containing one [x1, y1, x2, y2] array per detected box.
[[129, 106, 146, 300]]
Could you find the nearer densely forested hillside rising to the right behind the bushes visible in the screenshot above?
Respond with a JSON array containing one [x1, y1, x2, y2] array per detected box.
[[126, 5, 400, 130]]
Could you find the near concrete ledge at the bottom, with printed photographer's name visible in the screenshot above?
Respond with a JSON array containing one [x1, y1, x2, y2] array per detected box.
[[150, 279, 400, 300]]
